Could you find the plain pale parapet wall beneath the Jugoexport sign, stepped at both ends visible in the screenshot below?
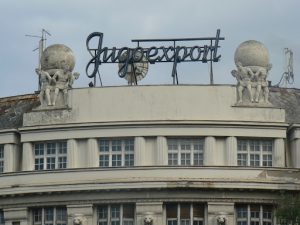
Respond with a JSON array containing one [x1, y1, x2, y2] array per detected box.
[[24, 85, 285, 126]]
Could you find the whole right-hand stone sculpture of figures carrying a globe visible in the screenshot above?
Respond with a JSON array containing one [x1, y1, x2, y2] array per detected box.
[[231, 40, 272, 106]]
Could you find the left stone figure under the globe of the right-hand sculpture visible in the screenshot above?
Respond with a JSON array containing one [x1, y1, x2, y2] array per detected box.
[[231, 62, 254, 103]]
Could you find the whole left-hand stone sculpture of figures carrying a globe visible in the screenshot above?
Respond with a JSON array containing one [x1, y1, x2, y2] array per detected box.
[[36, 44, 79, 107]]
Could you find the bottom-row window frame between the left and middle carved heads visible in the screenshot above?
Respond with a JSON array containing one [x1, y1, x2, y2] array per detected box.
[[95, 203, 136, 225]]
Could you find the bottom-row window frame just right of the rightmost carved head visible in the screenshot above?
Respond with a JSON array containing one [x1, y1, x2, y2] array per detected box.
[[235, 204, 275, 225]]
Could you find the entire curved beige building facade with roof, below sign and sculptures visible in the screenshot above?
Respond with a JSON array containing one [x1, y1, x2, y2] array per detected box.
[[0, 85, 300, 225]]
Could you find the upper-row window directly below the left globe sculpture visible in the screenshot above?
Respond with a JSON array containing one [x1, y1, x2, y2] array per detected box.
[[34, 141, 67, 170]]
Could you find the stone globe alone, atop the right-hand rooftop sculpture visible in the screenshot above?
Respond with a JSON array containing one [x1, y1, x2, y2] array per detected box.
[[234, 40, 270, 72]]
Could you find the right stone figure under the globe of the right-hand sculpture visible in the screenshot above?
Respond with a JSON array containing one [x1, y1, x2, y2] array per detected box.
[[254, 64, 272, 103]]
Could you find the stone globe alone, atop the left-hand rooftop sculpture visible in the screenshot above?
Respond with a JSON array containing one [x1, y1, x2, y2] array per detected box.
[[41, 44, 75, 71]]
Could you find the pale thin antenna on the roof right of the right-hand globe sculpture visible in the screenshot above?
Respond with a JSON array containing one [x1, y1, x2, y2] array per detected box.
[[276, 48, 294, 88]]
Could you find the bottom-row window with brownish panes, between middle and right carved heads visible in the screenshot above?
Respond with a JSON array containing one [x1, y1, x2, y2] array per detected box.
[[166, 203, 205, 225]]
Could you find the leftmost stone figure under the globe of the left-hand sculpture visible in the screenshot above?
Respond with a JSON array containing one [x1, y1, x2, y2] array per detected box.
[[35, 68, 55, 106]]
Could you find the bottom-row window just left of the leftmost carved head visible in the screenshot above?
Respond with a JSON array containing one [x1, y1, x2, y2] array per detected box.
[[32, 207, 68, 225]]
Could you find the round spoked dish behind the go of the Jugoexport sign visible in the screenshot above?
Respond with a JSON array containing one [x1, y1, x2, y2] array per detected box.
[[118, 51, 149, 83]]
